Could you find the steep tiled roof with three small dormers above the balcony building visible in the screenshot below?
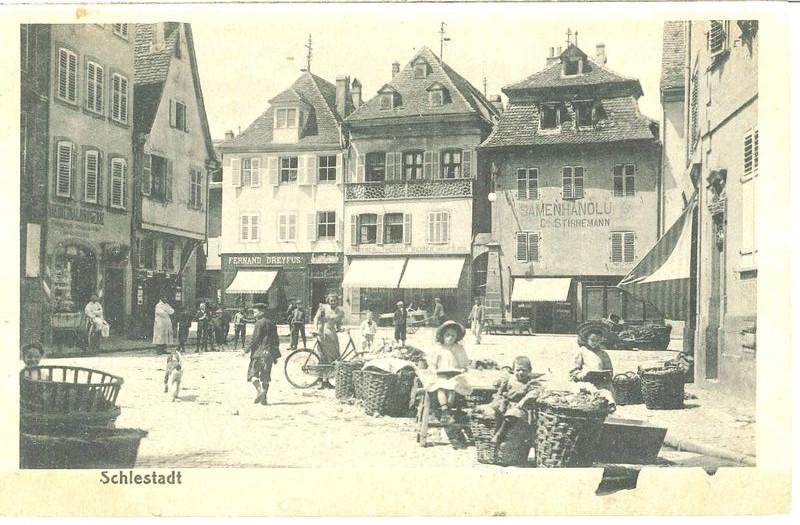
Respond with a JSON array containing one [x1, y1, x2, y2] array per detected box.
[[347, 47, 498, 122]]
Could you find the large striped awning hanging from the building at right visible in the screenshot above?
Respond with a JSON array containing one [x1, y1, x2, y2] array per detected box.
[[618, 195, 697, 321]]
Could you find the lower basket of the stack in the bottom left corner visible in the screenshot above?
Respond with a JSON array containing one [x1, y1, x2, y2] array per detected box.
[[20, 428, 147, 469]]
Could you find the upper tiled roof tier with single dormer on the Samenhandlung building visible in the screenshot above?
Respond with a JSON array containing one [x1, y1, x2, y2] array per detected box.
[[503, 46, 642, 96]]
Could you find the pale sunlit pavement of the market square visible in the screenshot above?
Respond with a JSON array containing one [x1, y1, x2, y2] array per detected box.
[[51, 329, 755, 468]]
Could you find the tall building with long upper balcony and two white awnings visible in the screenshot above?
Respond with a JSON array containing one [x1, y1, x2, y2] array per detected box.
[[343, 47, 499, 322]]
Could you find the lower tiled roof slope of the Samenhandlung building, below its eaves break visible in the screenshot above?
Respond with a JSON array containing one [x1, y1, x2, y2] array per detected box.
[[481, 96, 657, 147]]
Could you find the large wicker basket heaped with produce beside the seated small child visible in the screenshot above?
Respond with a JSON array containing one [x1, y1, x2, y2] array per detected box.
[[536, 391, 612, 467]]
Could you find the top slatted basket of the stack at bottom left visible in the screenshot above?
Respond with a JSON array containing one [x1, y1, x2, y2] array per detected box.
[[20, 365, 123, 417]]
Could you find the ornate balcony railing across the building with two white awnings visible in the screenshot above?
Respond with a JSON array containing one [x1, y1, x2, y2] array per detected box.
[[344, 179, 473, 201]]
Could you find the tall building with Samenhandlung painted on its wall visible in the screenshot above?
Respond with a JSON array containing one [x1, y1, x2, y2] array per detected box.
[[476, 44, 661, 333]]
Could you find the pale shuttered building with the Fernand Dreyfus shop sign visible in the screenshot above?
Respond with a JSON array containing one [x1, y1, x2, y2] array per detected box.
[[219, 72, 352, 313]]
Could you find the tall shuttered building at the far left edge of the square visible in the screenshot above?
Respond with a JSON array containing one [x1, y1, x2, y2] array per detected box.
[[20, 24, 134, 348]]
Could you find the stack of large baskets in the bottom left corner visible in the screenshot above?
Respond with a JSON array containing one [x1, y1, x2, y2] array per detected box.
[[20, 366, 147, 468]]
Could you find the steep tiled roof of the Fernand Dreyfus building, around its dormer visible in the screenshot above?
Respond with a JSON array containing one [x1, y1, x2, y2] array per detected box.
[[220, 73, 342, 150]]
